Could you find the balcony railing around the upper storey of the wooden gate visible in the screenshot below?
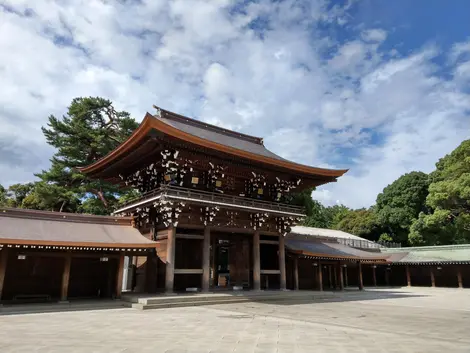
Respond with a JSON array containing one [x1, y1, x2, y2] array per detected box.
[[114, 185, 305, 216]]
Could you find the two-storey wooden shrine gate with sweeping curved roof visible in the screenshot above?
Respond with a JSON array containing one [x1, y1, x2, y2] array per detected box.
[[81, 107, 346, 292]]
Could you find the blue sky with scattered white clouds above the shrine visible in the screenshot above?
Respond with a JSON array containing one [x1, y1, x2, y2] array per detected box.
[[0, 0, 470, 208]]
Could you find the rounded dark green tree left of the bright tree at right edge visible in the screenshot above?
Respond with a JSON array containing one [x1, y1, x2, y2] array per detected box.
[[375, 172, 429, 244]]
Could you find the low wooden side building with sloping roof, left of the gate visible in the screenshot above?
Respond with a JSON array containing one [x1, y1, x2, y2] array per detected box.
[[0, 207, 155, 303]]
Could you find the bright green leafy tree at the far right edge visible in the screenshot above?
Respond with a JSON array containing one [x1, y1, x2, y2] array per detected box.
[[409, 140, 470, 245]]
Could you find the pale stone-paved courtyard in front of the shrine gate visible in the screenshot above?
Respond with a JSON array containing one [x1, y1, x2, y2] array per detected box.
[[0, 288, 470, 353]]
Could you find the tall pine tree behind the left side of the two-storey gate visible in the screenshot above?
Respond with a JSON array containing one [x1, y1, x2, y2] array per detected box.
[[35, 97, 138, 214]]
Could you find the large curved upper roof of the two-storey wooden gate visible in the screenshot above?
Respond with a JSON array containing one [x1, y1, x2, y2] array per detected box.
[[80, 107, 347, 178]]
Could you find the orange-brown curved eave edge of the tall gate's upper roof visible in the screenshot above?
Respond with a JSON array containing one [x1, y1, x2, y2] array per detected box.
[[78, 111, 348, 177]]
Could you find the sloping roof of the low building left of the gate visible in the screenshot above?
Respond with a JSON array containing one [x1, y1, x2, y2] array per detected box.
[[0, 208, 155, 248]]
